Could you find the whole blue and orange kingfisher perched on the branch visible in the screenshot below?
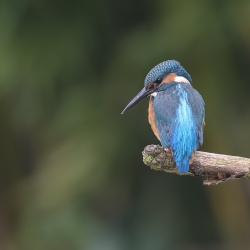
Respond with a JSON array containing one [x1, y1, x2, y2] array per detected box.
[[121, 60, 205, 173]]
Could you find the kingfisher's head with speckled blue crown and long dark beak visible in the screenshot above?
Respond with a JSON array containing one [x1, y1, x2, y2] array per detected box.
[[122, 60, 192, 114]]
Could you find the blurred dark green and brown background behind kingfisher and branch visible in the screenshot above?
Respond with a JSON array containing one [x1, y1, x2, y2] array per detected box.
[[0, 0, 250, 250]]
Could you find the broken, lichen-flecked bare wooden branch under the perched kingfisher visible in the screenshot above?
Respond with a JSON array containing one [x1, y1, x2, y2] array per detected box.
[[142, 145, 250, 185]]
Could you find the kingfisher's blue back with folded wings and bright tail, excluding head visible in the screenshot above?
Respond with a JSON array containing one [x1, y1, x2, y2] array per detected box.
[[153, 84, 205, 173]]
